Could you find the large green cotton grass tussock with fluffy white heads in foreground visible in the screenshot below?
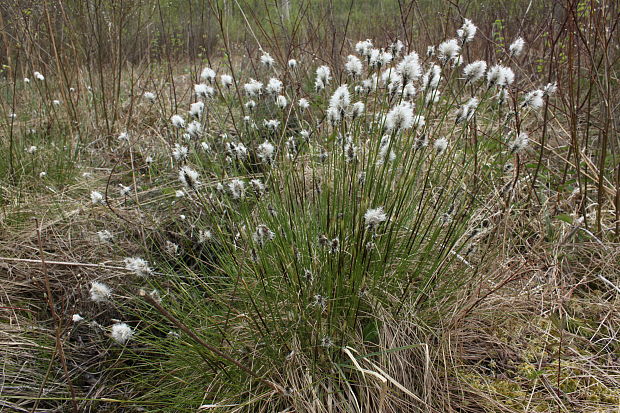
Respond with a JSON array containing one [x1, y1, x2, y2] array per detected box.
[[77, 17, 560, 412]]
